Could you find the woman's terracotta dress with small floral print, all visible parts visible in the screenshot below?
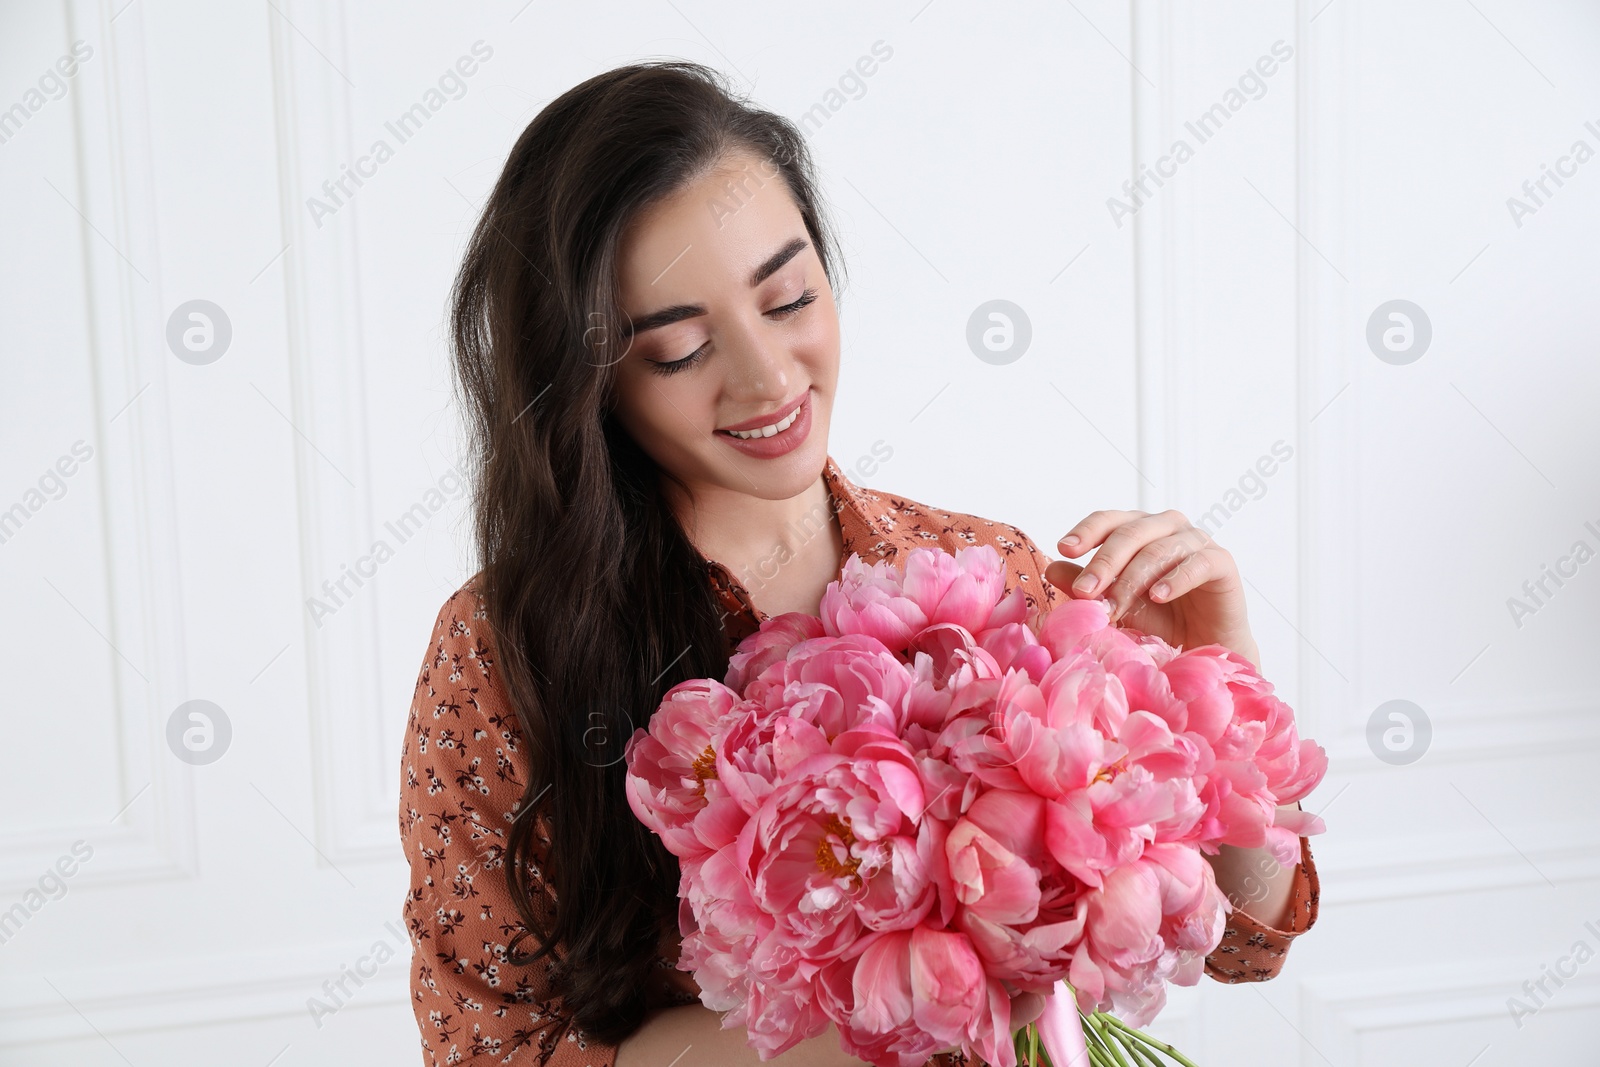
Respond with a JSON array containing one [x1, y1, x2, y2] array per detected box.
[[400, 456, 1318, 1067]]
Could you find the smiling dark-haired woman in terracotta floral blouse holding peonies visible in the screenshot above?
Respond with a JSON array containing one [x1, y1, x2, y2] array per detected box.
[[400, 62, 1317, 1067]]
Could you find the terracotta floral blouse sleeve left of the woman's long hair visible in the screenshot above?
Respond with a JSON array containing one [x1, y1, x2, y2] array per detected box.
[[400, 581, 616, 1067]]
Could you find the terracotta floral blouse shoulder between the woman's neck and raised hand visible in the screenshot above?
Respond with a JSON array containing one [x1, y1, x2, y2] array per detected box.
[[848, 473, 1064, 611]]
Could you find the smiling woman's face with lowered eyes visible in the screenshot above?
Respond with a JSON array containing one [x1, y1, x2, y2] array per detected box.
[[616, 152, 838, 511]]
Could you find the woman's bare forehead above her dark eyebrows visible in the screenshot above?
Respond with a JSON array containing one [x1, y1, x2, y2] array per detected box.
[[618, 152, 805, 306]]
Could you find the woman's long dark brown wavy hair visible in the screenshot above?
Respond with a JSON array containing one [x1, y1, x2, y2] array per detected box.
[[451, 61, 840, 1043]]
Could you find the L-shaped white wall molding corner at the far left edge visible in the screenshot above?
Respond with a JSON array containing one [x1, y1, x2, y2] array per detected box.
[[0, 0, 195, 904]]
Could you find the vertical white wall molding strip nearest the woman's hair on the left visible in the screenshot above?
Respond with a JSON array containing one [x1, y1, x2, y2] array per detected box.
[[272, 2, 398, 862]]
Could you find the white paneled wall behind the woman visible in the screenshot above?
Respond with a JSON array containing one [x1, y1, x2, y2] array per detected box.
[[0, 0, 1600, 1067]]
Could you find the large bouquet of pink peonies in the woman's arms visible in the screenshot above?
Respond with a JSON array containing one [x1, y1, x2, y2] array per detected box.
[[626, 545, 1326, 1067]]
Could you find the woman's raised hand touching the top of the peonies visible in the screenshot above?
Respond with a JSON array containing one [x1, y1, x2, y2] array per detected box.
[[1045, 510, 1261, 669]]
